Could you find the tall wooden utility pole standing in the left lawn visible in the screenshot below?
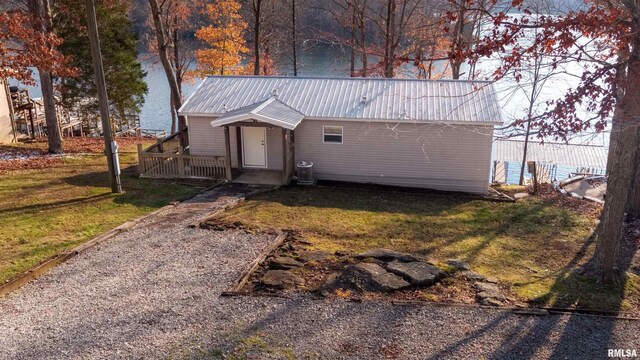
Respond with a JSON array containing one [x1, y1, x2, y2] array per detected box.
[[87, 0, 122, 194]]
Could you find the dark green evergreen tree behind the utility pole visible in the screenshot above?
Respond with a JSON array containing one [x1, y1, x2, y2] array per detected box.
[[54, 0, 148, 119]]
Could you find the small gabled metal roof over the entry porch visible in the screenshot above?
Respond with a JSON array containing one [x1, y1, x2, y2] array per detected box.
[[211, 96, 304, 130]]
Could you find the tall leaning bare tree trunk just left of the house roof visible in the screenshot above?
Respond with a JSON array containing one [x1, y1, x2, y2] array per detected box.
[[149, 0, 187, 143]]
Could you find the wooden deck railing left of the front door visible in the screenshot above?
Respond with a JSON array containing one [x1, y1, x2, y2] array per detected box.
[[138, 145, 231, 180]]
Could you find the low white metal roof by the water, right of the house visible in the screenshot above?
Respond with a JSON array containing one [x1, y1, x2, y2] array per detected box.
[[493, 140, 608, 169]]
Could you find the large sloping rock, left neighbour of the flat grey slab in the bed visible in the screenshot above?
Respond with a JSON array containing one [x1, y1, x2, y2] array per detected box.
[[333, 263, 410, 292]]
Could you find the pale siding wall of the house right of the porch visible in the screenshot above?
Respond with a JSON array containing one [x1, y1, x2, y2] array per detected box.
[[295, 119, 493, 193]]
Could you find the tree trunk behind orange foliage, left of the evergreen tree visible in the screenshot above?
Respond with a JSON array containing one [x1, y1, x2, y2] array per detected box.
[[28, 0, 62, 154]]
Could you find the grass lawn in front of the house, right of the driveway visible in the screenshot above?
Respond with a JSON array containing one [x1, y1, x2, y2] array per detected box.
[[221, 187, 640, 310]]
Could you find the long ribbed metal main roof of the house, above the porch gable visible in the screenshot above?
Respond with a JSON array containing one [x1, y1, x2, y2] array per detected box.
[[180, 76, 502, 125]]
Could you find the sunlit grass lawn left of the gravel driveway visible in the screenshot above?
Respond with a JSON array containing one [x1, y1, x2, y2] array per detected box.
[[0, 140, 197, 283]]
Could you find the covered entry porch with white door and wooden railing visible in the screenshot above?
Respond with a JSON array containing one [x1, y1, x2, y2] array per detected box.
[[138, 105, 295, 185]]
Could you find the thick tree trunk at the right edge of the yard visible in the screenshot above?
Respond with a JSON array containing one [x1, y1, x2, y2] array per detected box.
[[594, 47, 640, 282]]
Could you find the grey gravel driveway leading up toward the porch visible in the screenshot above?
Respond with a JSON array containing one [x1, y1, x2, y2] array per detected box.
[[0, 188, 640, 359]]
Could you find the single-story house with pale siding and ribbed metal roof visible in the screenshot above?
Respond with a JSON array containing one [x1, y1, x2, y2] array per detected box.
[[152, 76, 501, 193]]
